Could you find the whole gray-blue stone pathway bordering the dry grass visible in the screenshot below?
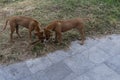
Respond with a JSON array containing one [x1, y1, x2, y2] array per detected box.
[[0, 34, 120, 80]]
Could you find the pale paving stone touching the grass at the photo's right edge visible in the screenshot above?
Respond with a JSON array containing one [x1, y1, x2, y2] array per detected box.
[[97, 34, 120, 56]]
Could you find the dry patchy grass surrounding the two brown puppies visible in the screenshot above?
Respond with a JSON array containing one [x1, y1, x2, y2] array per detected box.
[[0, 0, 120, 64]]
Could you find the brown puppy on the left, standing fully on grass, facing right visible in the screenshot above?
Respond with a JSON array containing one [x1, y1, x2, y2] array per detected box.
[[3, 16, 44, 42]]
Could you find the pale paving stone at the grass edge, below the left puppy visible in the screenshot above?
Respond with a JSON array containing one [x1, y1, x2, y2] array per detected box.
[[26, 57, 52, 73]]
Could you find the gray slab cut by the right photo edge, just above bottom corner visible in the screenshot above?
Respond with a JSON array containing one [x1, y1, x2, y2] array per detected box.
[[105, 55, 120, 74]]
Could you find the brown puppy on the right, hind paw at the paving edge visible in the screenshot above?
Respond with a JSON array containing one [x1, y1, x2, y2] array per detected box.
[[44, 18, 85, 45]]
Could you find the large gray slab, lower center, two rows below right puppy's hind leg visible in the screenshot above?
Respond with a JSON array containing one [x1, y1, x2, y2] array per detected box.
[[64, 51, 95, 75]]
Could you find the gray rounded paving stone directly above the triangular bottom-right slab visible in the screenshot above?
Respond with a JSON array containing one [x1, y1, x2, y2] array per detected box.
[[82, 46, 110, 64]]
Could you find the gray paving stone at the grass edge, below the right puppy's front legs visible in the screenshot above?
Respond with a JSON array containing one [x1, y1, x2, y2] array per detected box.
[[47, 50, 70, 63]]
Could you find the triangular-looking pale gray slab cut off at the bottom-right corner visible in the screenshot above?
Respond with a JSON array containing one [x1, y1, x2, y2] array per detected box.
[[74, 64, 120, 80]]
